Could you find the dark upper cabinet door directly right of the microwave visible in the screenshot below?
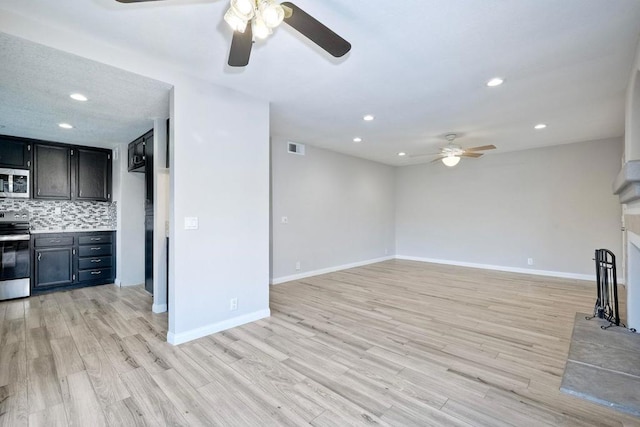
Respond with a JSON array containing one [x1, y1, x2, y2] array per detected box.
[[33, 144, 71, 200]]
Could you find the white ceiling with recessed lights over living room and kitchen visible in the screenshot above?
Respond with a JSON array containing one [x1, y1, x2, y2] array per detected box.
[[0, 0, 640, 165]]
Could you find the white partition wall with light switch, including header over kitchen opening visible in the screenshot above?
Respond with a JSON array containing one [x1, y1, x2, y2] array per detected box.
[[0, 13, 269, 344]]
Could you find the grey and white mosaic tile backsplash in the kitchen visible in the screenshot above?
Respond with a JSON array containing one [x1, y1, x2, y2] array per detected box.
[[0, 199, 118, 231]]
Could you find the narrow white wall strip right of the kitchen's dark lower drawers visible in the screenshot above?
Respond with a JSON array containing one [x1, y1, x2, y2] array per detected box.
[[113, 143, 144, 286]]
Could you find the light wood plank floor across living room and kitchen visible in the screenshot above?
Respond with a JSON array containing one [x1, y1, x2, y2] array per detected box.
[[0, 260, 640, 426]]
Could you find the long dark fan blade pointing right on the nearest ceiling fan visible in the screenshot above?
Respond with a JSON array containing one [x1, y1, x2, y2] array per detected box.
[[282, 2, 351, 58]]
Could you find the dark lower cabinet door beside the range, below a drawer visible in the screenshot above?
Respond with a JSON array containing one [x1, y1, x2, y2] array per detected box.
[[34, 247, 74, 288]]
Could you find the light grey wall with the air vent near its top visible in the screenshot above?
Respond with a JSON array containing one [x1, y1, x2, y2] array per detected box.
[[271, 140, 395, 283]]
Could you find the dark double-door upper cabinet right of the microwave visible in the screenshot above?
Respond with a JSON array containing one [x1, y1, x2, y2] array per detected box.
[[33, 144, 111, 202]]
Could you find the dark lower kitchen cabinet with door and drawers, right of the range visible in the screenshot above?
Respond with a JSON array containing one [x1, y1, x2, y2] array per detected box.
[[31, 231, 115, 294]]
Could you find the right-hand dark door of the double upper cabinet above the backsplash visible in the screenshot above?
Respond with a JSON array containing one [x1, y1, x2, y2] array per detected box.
[[76, 148, 111, 202]]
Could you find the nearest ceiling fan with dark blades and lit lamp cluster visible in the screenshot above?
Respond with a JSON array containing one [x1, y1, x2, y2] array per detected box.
[[116, 0, 351, 67]]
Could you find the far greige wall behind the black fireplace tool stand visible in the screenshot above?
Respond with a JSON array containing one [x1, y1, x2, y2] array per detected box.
[[396, 138, 622, 278]]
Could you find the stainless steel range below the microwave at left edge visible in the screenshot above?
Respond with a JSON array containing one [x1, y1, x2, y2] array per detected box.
[[0, 212, 31, 301]]
